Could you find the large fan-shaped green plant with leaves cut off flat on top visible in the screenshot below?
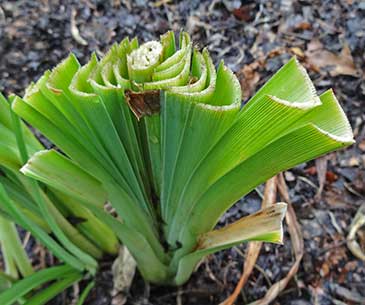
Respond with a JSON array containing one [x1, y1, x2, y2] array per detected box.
[[12, 32, 353, 285]]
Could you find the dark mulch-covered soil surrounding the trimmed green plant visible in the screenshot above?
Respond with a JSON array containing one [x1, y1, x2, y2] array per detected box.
[[0, 0, 365, 305]]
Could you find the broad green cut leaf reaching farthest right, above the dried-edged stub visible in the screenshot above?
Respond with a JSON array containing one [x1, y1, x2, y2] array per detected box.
[[176, 92, 353, 251]]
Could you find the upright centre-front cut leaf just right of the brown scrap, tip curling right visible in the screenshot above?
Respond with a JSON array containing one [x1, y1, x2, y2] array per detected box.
[[161, 60, 241, 239]]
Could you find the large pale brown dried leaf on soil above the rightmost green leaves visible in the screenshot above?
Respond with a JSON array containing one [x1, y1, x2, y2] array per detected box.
[[305, 39, 360, 77]]
